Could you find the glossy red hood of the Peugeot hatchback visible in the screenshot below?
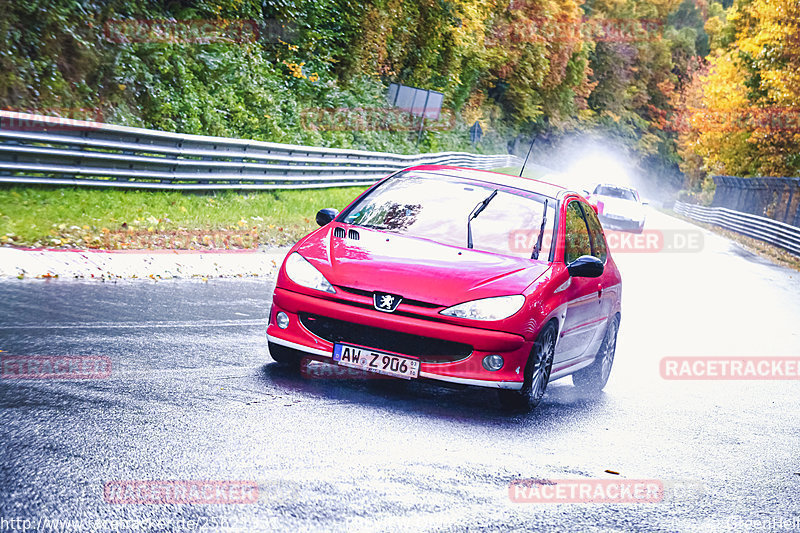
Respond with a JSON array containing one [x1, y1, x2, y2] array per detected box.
[[295, 223, 549, 306]]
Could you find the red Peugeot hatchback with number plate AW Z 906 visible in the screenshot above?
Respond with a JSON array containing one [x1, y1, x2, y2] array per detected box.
[[267, 165, 621, 410]]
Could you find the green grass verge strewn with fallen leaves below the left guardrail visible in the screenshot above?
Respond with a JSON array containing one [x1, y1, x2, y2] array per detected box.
[[0, 186, 364, 250]]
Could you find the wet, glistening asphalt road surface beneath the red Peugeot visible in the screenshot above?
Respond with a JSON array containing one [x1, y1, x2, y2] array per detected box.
[[0, 213, 800, 531]]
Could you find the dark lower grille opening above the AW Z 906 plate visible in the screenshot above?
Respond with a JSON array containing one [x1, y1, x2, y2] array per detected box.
[[300, 313, 472, 363]]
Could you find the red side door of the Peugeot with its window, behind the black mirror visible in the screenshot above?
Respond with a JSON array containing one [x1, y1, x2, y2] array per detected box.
[[554, 199, 603, 362]]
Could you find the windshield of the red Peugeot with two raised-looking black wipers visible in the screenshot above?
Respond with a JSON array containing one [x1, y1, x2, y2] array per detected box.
[[342, 173, 556, 260]]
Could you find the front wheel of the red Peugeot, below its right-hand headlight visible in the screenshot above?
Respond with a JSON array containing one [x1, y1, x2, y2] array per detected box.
[[497, 321, 558, 413]]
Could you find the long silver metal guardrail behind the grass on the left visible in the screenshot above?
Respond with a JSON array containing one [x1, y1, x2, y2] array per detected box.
[[0, 111, 522, 190]]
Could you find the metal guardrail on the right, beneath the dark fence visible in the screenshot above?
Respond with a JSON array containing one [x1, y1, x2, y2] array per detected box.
[[673, 202, 800, 256]]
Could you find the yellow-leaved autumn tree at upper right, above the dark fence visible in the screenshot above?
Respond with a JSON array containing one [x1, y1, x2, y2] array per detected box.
[[678, 0, 800, 182]]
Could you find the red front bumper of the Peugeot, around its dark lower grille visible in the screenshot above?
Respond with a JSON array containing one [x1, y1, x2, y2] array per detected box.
[[267, 287, 532, 390]]
